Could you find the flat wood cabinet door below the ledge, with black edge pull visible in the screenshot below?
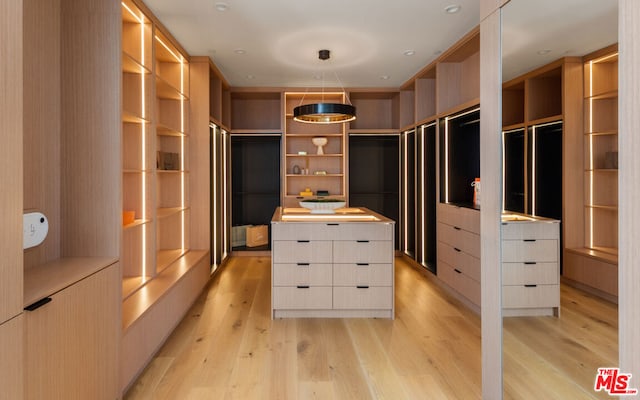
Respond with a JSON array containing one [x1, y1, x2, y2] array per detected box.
[[24, 263, 120, 400]]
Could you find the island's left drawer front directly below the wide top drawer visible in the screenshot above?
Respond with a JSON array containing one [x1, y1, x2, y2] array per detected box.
[[271, 240, 333, 264]]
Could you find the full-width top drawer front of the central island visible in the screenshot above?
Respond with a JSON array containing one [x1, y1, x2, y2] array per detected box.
[[271, 222, 394, 240]]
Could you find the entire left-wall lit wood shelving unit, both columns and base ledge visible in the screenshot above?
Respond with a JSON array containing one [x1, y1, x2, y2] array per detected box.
[[120, 0, 211, 390]]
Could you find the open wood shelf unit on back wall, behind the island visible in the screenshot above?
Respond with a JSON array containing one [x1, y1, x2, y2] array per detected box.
[[281, 92, 347, 207]]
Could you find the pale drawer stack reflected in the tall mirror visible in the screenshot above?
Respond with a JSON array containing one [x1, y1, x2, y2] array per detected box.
[[502, 219, 560, 316]]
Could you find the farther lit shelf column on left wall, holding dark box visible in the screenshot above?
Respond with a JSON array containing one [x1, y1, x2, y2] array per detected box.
[[153, 31, 190, 273]]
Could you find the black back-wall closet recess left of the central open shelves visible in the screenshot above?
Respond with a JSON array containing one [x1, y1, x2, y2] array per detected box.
[[231, 135, 281, 250]]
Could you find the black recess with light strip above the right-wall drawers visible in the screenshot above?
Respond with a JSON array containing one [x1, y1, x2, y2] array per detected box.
[[440, 108, 480, 208]]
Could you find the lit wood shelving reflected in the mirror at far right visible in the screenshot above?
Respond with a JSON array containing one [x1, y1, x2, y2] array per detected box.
[[564, 45, 618, 300]]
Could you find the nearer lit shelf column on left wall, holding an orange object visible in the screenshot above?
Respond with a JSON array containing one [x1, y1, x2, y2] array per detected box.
[[122, 1, 155, 298]]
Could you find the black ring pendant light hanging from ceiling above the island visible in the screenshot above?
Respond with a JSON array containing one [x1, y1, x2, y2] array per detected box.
[[293, 50, 356, 124]]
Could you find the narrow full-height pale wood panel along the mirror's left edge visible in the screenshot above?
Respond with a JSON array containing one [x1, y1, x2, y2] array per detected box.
[[480, 4, 502, 399]]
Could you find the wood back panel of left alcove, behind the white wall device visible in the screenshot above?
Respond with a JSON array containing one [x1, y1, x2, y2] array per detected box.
[[22, 0, 62, 269]]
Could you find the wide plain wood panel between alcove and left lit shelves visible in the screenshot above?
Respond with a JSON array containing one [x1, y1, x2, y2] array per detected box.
[[60, 0, 122, 256]]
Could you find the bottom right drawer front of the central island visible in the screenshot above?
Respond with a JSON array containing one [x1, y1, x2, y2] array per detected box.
[[333, 286, 393, 310]]
